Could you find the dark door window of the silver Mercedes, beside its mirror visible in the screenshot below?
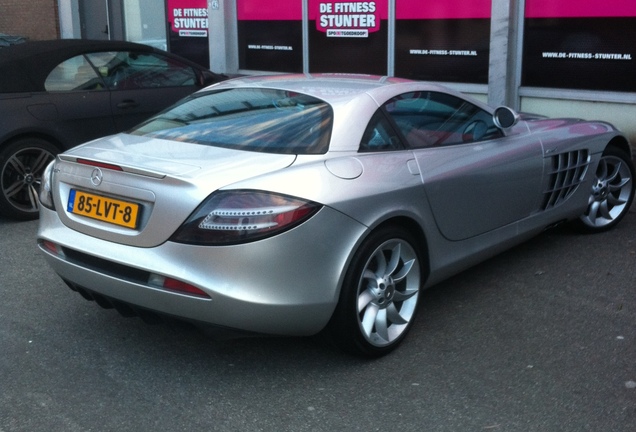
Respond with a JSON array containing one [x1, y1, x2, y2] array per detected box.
[[384, 92, 502, 148]]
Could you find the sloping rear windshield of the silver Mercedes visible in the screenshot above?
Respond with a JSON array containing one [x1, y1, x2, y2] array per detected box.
[[129, 88, 333, 154]]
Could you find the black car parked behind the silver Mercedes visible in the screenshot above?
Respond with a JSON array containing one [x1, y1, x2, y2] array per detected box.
[[0, 39, 227, 219]]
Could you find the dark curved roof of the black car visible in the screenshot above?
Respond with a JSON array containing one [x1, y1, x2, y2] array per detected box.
[[0, 39, 191, 93]]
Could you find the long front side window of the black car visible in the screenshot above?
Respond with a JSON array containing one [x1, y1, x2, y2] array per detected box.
[[88, 51, 197, 90]]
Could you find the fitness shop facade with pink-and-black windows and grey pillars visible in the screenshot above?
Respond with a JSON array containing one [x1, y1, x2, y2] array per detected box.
[[59, 0, 636, 142]]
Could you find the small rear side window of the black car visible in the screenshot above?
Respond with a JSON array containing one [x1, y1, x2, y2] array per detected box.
[[44, 55, 104, 92]]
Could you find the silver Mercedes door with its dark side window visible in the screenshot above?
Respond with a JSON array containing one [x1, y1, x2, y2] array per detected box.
[[384, 92, 543, 241]]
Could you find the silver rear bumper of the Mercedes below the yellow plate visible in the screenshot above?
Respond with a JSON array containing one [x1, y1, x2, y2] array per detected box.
[[38, 204, 365, 336]]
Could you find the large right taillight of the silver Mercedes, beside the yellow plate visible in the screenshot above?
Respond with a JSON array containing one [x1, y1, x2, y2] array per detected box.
[[171, 191, 321, 245]]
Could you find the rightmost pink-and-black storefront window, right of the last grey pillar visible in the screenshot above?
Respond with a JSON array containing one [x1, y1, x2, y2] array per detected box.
[[521, 0, 636, 92]]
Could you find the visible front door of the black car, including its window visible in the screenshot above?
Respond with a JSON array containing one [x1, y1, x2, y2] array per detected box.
[[88, 51, 199, 131]]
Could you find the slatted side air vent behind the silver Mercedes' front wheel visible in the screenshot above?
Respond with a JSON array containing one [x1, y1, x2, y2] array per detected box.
[[543, 150, 590, 210]]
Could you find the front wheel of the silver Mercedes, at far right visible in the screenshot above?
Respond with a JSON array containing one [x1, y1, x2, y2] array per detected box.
[[575, 147, 635, 233]]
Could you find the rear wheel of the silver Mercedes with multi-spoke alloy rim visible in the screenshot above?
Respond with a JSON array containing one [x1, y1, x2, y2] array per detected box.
[[327, 227, 422, 357]]
